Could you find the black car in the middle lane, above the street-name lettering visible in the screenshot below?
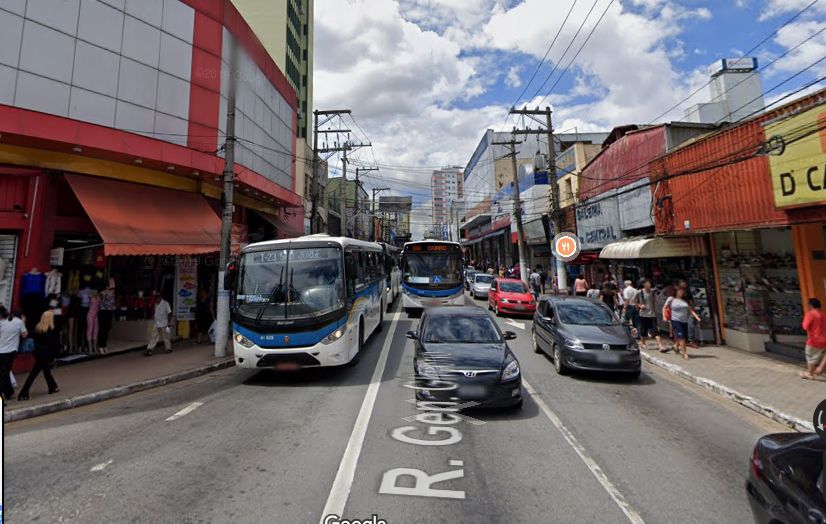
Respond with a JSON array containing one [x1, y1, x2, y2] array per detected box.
[[407, 306, 522, 408]]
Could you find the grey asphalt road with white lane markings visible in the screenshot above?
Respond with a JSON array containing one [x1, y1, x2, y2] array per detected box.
[[3, 298, 783, 524]]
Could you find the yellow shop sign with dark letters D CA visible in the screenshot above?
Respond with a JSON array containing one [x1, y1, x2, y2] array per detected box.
[[766, 106, 826, 208]]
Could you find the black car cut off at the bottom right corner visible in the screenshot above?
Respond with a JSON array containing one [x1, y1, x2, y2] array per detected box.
[[746, 433, 826, 524]]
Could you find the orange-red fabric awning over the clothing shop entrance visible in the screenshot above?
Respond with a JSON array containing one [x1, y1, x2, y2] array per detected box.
[[66, 175, 221, 255]]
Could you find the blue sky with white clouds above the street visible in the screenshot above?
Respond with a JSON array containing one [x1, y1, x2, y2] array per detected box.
[[313, 0, 826, 238]]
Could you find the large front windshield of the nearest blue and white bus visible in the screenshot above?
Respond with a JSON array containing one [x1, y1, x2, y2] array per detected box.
[[236, 247, 344, 321]]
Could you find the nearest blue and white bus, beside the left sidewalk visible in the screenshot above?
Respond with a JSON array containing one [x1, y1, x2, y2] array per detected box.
[[229, 235, 387, 370]]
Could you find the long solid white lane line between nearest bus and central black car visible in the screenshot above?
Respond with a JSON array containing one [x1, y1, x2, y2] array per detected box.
[[319, 311, 400, 524]]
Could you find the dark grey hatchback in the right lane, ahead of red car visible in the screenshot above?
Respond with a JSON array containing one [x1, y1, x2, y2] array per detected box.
[[532, 296, 642, 377]]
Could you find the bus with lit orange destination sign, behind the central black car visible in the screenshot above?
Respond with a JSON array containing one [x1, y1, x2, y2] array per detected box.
[[402, 240, 465, 314]]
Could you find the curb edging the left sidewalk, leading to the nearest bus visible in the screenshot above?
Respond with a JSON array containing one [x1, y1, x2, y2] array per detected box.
[[3, 358, 235, 423]]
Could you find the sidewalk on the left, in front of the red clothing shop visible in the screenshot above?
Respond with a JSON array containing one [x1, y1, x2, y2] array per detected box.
[[3, 340, 235, 422]]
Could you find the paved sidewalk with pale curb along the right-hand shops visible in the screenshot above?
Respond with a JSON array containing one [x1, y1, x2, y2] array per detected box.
[[642, 343, 826, 431]]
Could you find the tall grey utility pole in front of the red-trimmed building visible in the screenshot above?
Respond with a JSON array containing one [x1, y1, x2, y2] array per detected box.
[[215, 38, 238, 358]]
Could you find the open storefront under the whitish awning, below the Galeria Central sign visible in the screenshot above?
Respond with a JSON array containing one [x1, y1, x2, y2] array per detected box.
[[599, 235, 721, 343]]
